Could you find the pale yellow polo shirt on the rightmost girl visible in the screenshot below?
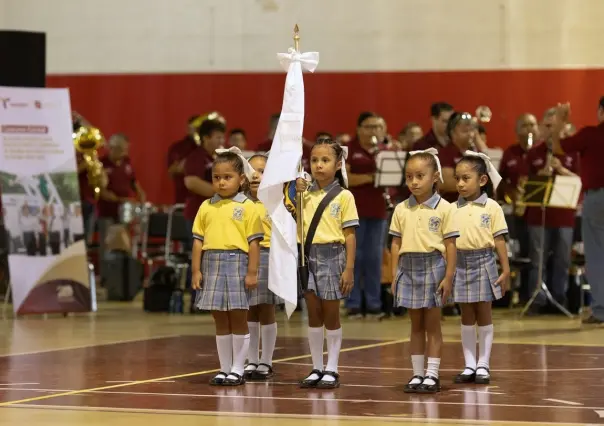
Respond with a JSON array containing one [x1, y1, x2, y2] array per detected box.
[[453, 193, 508, 250]]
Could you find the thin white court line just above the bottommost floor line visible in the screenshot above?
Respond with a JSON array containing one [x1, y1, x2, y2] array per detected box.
[[2, 389, 604, 410]]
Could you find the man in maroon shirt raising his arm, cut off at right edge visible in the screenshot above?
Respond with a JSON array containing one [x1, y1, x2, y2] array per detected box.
[[552, 96, 604, 325]]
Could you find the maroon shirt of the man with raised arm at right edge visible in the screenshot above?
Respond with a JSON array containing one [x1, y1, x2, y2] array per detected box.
[[560, 122, 604, 191]]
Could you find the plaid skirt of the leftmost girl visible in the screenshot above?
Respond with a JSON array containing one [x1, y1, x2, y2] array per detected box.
[[195, 250, 249, 311]]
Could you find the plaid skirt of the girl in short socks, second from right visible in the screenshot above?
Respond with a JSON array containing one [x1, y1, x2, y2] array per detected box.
[[394, 251, 449, 309]]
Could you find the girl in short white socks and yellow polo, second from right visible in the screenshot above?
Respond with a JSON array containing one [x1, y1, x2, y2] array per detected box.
[[390, 148, 459, 393]]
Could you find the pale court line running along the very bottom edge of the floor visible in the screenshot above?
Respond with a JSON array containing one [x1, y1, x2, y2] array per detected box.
[[0, 404, 585, 426]]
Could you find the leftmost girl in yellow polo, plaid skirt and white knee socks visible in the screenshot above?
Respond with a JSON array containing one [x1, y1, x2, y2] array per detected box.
[[191, 148, 264, 386]]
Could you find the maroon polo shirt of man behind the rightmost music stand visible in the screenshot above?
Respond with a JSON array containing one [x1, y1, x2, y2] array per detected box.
[[525, 143, 579, 228]]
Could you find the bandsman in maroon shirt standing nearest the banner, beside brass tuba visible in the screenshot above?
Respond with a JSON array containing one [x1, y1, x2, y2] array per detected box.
[[97, 134, 146, 277]]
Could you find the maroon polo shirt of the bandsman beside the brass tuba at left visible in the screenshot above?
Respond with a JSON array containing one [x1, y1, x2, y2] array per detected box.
[[97, 156, 136, 220]]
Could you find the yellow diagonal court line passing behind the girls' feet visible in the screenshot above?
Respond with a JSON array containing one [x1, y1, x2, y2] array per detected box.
[[0, 339, 408, 407]]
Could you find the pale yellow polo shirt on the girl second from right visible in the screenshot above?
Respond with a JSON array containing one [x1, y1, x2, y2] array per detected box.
[[390, 193, 459, 254]]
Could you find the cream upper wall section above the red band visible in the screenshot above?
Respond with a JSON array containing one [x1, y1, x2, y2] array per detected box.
[[0, 0, 604, 74]]
